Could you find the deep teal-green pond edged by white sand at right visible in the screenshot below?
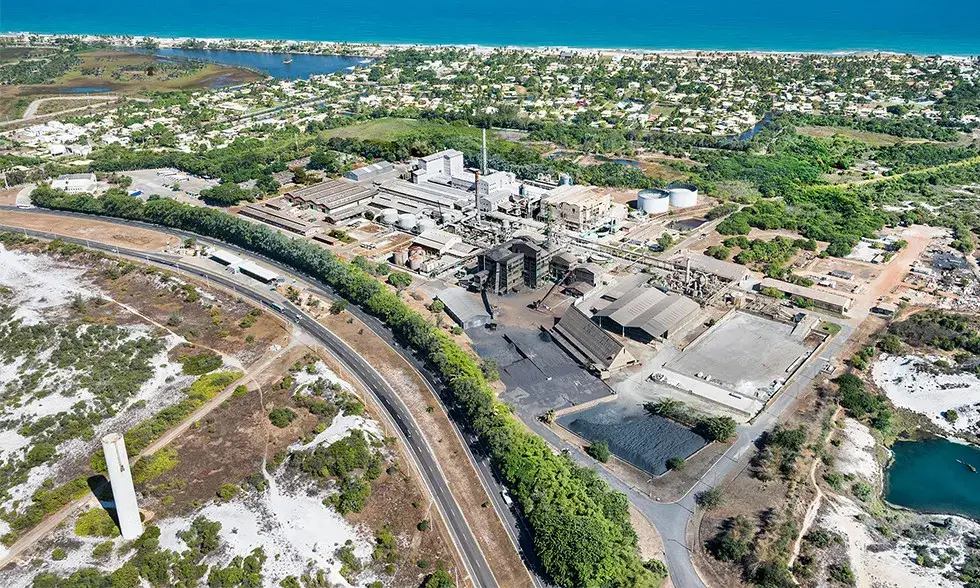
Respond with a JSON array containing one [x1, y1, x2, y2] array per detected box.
[[885, 439, 980, 520]]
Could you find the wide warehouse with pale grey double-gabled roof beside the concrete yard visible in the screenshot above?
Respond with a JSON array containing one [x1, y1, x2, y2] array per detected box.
[[596, 286, 701, 343]]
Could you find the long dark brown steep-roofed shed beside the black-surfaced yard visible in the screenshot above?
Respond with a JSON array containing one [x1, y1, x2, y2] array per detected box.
[[551, 306, 636, 374]]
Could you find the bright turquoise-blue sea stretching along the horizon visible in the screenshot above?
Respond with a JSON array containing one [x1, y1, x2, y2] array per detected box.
[[0, 0, 980, 55]]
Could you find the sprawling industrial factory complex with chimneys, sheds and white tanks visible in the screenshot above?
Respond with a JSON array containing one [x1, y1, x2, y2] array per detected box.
[[226, 143, 851, 428]]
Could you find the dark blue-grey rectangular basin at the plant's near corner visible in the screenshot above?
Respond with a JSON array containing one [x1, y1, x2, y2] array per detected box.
[[557, 402, 708, 476]]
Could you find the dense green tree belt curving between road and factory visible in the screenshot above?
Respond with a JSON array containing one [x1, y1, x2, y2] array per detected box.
[[32, 187, 655, 588]]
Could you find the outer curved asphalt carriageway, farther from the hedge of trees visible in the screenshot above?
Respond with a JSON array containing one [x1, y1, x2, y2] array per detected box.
[[0, 220, 497, 588]]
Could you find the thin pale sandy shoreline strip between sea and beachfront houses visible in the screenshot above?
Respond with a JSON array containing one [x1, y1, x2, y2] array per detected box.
[[0, 31, 980, 61]]
